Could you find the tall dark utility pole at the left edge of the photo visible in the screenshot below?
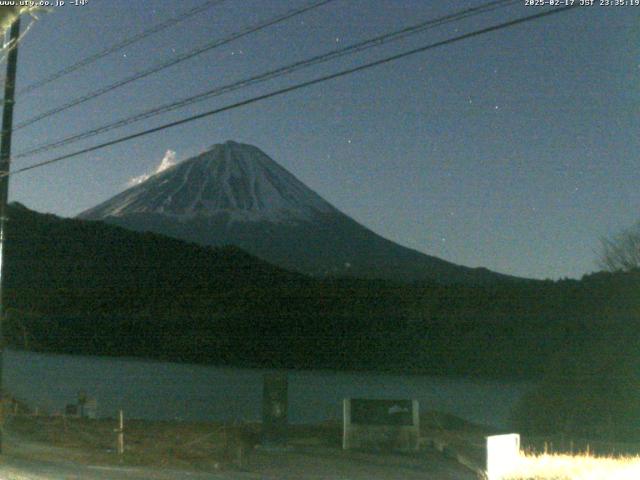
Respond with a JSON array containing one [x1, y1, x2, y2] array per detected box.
[[0, 15, 20, 453]]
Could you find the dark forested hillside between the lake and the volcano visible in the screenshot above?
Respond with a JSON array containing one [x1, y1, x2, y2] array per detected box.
[[4, 205, 640, 378]]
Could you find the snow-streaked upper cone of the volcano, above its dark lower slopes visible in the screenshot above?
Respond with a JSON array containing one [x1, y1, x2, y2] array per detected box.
[[80, 141, 336, 223]]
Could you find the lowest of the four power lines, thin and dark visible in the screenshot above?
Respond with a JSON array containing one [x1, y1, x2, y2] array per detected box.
[[0, 4, 579, 177]]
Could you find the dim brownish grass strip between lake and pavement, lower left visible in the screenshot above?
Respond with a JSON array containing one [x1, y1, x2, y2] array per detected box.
[[4, 416, 341, 472]]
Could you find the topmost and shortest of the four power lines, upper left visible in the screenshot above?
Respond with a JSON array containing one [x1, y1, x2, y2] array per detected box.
[[18, 0, 227, 95]]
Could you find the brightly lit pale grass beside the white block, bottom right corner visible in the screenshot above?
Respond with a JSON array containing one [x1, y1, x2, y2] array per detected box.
[[504, 454, 640, 480]]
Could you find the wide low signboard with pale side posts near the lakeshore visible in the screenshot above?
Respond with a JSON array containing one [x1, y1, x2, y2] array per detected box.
[[342, 398, 420, 451]]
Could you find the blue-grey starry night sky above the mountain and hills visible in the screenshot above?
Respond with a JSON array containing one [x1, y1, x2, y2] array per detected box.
[[2, 0, 640, 279]]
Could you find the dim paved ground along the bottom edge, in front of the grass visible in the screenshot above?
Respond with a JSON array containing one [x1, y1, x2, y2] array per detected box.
[[0, 436, 476, 480]]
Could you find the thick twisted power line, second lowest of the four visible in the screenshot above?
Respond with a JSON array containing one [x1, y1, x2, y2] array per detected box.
[[14, 0, 520, 159]]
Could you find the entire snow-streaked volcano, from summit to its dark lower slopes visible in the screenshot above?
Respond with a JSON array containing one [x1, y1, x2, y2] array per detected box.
[[78, 141, 515, 284]]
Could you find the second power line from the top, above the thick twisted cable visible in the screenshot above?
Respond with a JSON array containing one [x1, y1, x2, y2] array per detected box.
[[13, 0, 335, 132]]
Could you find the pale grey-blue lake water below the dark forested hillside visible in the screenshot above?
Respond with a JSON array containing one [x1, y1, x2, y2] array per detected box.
[[4, 350, 532, 428]]
